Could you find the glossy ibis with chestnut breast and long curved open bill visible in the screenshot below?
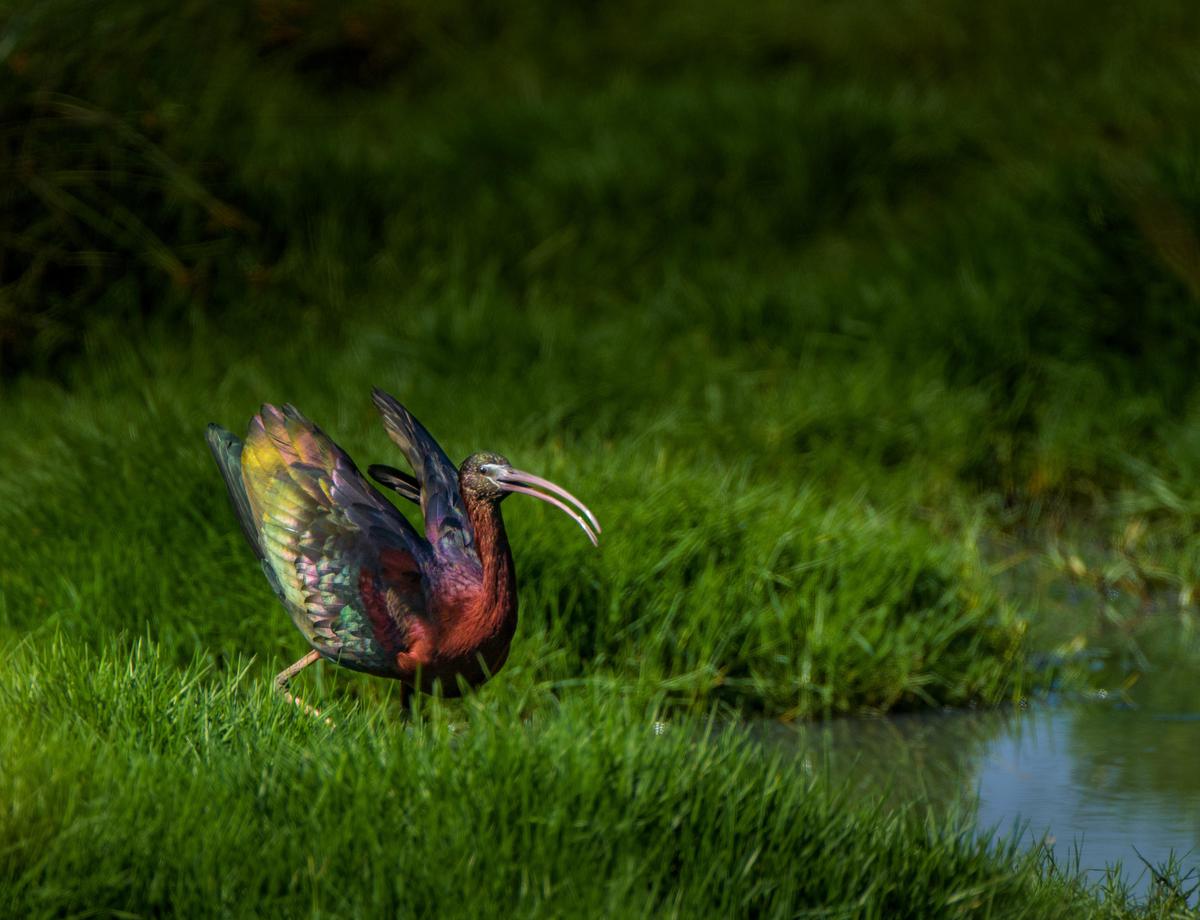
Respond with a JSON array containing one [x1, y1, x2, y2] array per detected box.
[[206, 387, 600, 715]]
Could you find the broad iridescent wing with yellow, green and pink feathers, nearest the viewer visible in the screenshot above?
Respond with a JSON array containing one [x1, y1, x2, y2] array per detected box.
[[241, 405, 430, 674]]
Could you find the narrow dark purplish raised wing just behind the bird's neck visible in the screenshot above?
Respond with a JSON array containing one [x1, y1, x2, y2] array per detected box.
[[372, 387, 474, 554]]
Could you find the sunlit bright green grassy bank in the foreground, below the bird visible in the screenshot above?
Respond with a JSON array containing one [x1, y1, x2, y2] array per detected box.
[[0, 637, 1190, 918]]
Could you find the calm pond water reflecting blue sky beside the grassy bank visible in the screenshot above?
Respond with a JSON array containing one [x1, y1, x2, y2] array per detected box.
[[768, 668, 1200, 894]]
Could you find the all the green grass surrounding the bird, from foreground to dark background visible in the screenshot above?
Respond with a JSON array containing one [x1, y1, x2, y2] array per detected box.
[[0, 0, 1200, 916]]
